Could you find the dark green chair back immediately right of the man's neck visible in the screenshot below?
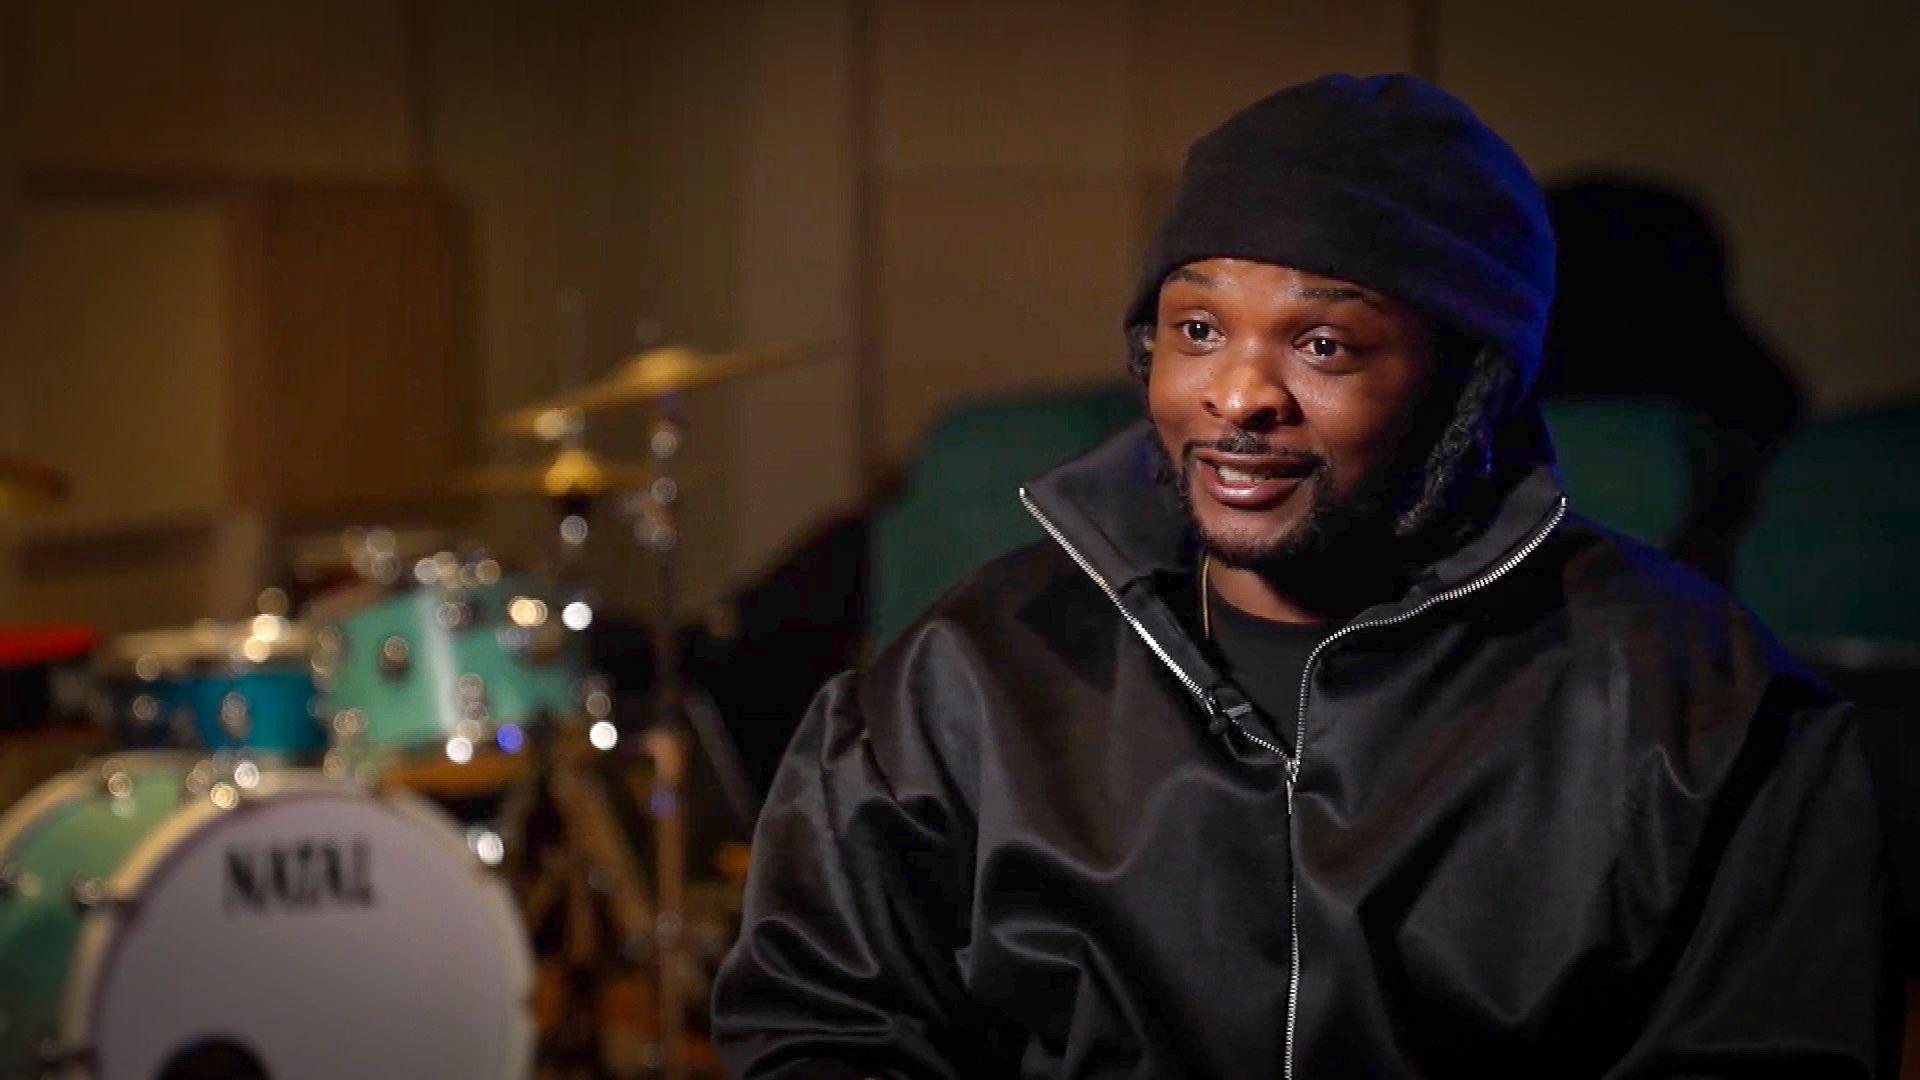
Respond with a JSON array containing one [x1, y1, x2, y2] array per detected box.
[[1544, 398, 1709, 548]]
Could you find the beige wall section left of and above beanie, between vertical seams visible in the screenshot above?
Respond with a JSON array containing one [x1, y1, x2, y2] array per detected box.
[[860, 0, 1417, 469]]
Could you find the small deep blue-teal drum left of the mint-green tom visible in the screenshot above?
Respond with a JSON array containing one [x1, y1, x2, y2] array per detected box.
[[98, 621, 326, 759]]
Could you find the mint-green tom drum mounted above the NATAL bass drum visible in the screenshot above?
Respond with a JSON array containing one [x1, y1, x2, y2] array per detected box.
[[321, 577, 586, 759]]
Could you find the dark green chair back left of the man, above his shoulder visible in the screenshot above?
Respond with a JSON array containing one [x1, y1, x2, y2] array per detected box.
[[870, 382, 1142, 646]]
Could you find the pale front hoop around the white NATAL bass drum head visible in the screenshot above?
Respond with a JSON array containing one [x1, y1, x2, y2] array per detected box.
[[55, 769, 534, 1080]]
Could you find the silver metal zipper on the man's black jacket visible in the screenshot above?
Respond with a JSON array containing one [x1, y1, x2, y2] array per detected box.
[[1020, 488, 1567, 1080]]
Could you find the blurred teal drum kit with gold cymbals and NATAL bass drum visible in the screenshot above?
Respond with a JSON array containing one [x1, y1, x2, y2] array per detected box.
[[0, 348, 818, 1080]]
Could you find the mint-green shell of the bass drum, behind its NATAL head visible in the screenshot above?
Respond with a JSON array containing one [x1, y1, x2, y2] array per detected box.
[[0, 751, 192, 1076]]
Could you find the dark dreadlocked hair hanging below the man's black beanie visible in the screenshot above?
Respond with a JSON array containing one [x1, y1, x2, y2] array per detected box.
[[1127, 311, 1515, 546]]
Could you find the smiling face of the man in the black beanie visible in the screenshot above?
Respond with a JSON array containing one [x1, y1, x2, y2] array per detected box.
[[1146, 259, 1436, 567]]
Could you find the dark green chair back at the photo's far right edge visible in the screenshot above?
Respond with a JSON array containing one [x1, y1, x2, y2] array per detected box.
[[1734, 402, 1920, 641]]
